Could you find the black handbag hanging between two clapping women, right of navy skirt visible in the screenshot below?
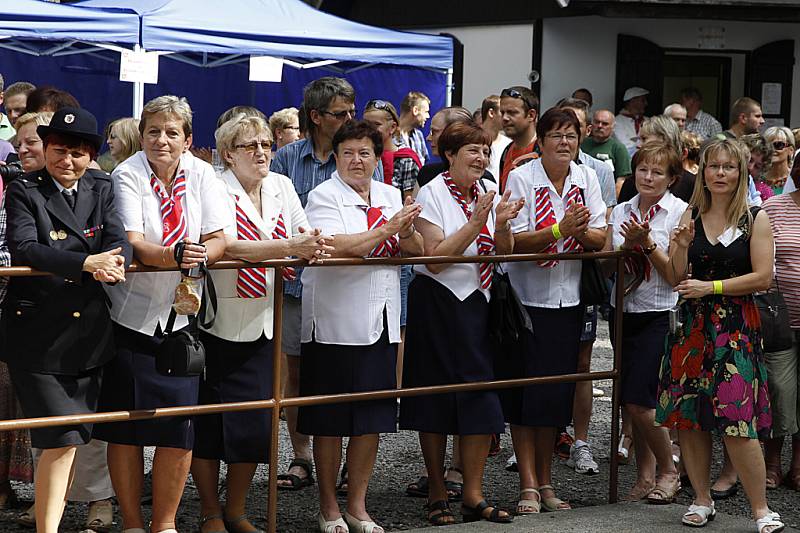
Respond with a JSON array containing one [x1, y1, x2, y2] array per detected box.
[[489, 264, 533, 346]]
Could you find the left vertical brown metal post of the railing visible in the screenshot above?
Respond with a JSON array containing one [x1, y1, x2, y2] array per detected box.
[[267, 267, 283, 533]]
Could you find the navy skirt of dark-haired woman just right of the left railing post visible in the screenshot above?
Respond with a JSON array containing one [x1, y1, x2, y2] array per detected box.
[[297, 322, 397, 437]]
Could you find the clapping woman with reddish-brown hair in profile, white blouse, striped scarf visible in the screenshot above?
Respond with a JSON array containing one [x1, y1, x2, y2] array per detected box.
[[400, 121, 524, 526]]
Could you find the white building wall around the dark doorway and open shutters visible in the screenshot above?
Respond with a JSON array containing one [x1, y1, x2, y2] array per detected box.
[[536, 17, 800, 126]]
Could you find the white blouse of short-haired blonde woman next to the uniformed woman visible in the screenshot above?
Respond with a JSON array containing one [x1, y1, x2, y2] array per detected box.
[[106, 152, 235, 335]]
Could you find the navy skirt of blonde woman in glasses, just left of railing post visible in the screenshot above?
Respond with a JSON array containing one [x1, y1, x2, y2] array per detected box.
[[194, 332, 273, 464]]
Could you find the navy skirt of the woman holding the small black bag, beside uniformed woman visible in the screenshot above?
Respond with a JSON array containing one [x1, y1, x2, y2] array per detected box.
[[92, 323, 200, 450]]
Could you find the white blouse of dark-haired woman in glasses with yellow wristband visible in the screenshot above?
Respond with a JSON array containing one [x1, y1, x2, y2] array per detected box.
[[506, 159, 606, 308]]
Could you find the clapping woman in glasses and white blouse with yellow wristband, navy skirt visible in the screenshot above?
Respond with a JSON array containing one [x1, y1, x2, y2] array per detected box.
[[503, 109, 606, 514]]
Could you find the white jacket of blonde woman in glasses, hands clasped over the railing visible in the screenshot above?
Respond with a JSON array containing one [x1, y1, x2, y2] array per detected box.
[[203, 170, 310, 342]]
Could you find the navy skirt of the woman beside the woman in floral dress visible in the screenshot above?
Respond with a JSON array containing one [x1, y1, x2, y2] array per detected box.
[[608, 311, 669, 409]]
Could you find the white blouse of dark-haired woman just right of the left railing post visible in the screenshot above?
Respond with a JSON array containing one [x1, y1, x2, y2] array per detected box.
[[300, 172, 403, 346]]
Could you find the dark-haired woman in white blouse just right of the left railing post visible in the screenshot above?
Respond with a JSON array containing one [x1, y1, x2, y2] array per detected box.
[[297, 122, 422, 533]]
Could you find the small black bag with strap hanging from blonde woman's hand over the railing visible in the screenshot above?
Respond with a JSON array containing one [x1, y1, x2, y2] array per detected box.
[[156, 264, 217, 378]]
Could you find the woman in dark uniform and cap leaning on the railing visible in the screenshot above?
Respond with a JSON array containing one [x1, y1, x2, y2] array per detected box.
[[2, 107, 131, 533]]
